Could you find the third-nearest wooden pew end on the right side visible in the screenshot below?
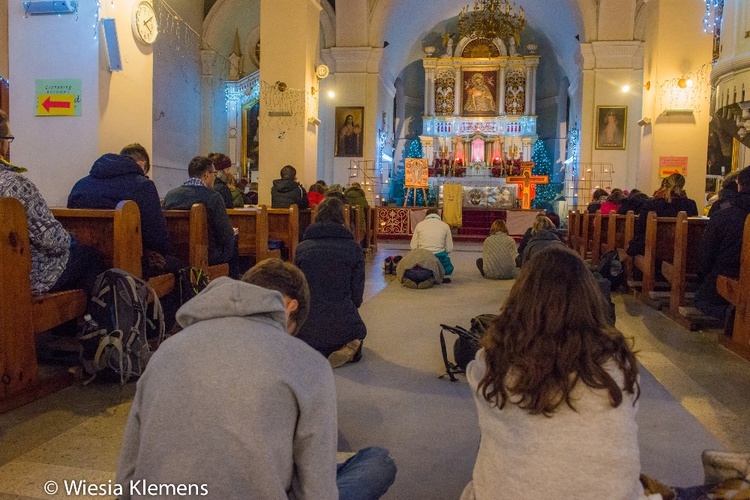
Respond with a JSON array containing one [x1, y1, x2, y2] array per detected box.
[[633, 212, 677, 309]]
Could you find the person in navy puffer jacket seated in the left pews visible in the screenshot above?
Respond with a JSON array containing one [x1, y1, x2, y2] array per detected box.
[[68, 144, 169, 277]]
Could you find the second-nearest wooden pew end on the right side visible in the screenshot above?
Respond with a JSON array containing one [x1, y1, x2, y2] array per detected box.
[[661, 212, 716, 330]]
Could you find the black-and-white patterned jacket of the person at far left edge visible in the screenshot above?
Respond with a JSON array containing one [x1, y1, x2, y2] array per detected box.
[[0, 161, 70, 295]]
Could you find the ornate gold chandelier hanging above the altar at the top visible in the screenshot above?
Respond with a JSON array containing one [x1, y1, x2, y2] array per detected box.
[[458, 0, 526, 40]]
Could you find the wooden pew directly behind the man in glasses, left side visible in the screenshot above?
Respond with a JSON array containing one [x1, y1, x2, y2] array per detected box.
[[164, 203, 229, 279]]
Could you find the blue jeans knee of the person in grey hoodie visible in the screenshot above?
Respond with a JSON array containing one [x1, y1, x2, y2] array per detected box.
[[336, 446, 396, 500]]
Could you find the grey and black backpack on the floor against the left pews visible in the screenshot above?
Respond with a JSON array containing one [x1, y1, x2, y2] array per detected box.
[[78, 269, 164, 384]]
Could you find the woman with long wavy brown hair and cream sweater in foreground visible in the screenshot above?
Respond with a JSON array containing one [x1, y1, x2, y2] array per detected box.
[[462, 248, 644, 499]]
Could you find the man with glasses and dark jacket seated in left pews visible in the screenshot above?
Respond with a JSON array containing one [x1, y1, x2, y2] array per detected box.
[[164, 156, 239, 279]]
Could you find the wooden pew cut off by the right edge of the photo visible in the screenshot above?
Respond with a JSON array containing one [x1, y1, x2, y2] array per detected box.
[[716, 215, 750, 360]]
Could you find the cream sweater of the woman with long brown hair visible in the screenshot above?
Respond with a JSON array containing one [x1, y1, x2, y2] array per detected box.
[[461, 350, 645, 500]]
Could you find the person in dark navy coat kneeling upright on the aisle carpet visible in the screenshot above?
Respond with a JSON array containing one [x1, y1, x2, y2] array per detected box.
[[295, 197, 367, 368]]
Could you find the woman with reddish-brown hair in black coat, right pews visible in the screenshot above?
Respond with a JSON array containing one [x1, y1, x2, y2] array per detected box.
[[627, 174, 698, 256]]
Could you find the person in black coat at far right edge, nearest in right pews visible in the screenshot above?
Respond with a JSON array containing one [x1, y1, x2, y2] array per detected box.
[[695, 167, 750, 322]]
